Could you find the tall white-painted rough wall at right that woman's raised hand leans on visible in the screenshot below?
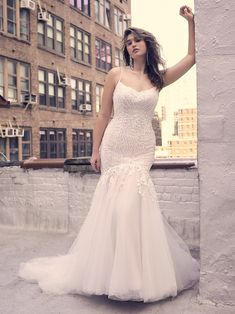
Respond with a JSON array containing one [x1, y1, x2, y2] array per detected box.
[[195, 0, 235, 305]]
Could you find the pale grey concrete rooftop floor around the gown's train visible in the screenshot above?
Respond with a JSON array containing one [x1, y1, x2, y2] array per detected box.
[[0, 228, 231, 314]]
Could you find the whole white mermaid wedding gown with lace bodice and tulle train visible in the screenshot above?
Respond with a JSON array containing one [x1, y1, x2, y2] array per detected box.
[[19, 68, 199, 302]]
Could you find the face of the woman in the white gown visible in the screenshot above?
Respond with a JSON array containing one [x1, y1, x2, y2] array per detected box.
[[125, 34, 147, 59]]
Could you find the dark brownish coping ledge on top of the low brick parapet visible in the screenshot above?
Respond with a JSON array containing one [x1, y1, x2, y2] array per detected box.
[[0, 157, 197, 173]]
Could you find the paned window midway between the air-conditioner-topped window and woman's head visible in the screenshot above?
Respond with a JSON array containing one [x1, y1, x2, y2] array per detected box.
[[70, 26, 91, 63]]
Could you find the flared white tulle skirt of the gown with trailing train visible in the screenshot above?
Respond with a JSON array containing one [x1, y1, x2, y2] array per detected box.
[[19, 164, 199, 302]]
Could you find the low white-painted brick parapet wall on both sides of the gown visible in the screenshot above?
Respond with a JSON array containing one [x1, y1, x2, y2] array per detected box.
[[0, 167, 199, 253]]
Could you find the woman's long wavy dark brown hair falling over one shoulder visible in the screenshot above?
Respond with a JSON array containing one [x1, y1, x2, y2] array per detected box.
[[122, 27, 165, 89]]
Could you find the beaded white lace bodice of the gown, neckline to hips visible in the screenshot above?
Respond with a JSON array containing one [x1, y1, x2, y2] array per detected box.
[[101, 76, 159, 171]]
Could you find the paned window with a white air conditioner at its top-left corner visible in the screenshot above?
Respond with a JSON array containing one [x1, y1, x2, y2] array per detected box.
[[38, 14, 64, 53]]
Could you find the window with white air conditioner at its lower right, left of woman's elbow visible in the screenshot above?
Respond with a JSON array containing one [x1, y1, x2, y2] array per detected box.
[[71, 79, 92, 111]]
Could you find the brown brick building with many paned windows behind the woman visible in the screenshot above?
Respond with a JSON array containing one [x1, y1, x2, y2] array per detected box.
[[0, 0, 131, 160]]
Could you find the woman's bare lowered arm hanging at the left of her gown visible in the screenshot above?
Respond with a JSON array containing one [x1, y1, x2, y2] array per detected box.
[[91, 68, 120, 171]]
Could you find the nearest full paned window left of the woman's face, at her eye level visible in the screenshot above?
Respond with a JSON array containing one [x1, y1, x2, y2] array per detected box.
[[95, 39, 112, 71]]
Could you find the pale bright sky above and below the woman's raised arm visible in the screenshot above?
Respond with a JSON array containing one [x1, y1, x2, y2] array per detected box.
[[131, 0, 196, 138]]
